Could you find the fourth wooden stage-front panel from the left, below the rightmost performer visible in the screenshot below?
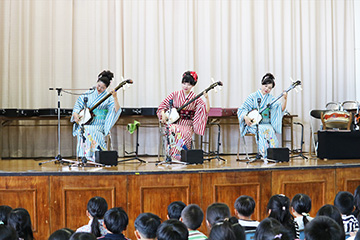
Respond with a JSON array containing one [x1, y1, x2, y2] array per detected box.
[[201, 171, 271, 220]]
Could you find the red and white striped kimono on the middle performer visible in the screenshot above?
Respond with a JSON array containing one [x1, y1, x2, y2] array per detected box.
[[157, 90, 208, 160]]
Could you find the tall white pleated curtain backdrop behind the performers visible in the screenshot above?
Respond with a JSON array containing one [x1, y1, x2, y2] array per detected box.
[[0, 0, 360, 157]]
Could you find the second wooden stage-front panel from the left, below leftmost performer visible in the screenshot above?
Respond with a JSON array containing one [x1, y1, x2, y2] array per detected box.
[[50, 175, 127, 232]]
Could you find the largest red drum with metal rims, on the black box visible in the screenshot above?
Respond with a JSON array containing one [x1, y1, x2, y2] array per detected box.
[[321, 111, 351, 129]]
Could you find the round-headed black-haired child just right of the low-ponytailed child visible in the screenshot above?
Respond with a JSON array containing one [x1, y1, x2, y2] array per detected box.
[[98, 207, 129, 240]]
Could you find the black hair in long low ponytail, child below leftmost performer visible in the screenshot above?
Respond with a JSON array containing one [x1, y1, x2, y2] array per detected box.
[[87, 197, 108, 237]]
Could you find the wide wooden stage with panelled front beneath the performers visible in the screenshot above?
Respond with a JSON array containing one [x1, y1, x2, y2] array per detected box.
[[0, 155, 360, 240]]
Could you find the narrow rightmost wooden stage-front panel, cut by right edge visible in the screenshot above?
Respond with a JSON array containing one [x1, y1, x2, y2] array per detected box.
[[336, 168, 360, 194]]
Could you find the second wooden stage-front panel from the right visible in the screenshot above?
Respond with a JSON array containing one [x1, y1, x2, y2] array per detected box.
[[272, 169, 335, 216]]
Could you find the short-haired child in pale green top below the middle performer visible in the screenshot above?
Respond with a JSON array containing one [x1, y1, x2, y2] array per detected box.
[[180, 204, 207, 240]]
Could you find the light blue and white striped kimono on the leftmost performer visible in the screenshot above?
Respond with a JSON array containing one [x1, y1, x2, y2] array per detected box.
[[71, 90, 121, 161]]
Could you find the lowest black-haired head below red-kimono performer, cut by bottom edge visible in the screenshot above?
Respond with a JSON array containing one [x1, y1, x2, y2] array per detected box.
[[156, 219, 189, 240]]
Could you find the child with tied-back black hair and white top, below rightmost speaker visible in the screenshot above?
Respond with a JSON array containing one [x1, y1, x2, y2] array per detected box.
[[291, 193, 313, 231]]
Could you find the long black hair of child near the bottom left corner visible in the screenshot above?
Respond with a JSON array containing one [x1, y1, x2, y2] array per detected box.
[[8, 208, 34, 240]]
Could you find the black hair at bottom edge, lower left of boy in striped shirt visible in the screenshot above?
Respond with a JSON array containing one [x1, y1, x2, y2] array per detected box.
[[209, 217, 245, 240]]
